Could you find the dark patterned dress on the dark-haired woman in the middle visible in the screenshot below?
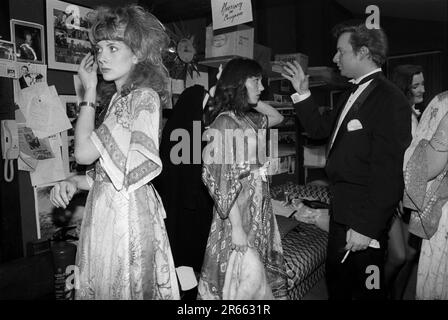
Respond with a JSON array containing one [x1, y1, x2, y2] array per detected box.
[[198, 112, 287, 300]]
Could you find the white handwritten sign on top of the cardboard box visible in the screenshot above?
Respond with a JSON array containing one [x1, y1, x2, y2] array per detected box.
[[211, 0, 253, 30]]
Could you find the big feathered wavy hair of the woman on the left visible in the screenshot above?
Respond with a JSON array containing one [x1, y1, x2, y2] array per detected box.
[[88, 4, 170, 103]]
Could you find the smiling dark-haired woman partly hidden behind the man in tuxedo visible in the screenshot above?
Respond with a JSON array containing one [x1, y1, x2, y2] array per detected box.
[[385, 64, 425, 300]]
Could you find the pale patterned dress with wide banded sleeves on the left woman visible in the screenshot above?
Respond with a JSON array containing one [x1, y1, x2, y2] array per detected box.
[[76, 88, 179, 299]]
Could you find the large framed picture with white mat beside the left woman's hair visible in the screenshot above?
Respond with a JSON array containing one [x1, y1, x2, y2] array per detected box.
[[46, 0, 93, 71]]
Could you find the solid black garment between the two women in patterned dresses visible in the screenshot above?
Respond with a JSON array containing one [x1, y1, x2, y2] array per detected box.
[[152, 85, 213, 272]]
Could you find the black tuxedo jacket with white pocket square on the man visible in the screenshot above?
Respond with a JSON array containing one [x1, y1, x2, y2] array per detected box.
[[294, 72, 412, 239]]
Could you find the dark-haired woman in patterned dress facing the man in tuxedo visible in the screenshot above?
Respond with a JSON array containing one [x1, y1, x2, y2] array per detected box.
[[198, 58, 286, 300]]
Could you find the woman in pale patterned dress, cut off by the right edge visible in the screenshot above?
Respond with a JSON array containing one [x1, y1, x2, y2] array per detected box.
[[403, 91, 448, 300]]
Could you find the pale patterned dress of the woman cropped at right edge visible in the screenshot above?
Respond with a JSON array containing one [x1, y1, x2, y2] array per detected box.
[[404, 91, 448, 300]]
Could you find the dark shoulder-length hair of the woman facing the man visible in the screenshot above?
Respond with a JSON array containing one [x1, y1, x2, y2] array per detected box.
[[210, 58, 263, 122]]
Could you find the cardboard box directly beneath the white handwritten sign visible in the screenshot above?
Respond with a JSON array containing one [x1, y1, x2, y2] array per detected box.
[[205, 24, 254, 59]]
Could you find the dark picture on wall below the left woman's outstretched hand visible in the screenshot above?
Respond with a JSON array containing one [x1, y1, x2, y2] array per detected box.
[[34, 184, 87, 243]]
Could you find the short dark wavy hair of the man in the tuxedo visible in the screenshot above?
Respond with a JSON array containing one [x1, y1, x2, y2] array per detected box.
[[332, 20, 389, 67]]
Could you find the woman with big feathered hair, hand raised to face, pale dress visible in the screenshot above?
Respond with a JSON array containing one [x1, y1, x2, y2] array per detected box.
[[51, 5, 179, 299]]
